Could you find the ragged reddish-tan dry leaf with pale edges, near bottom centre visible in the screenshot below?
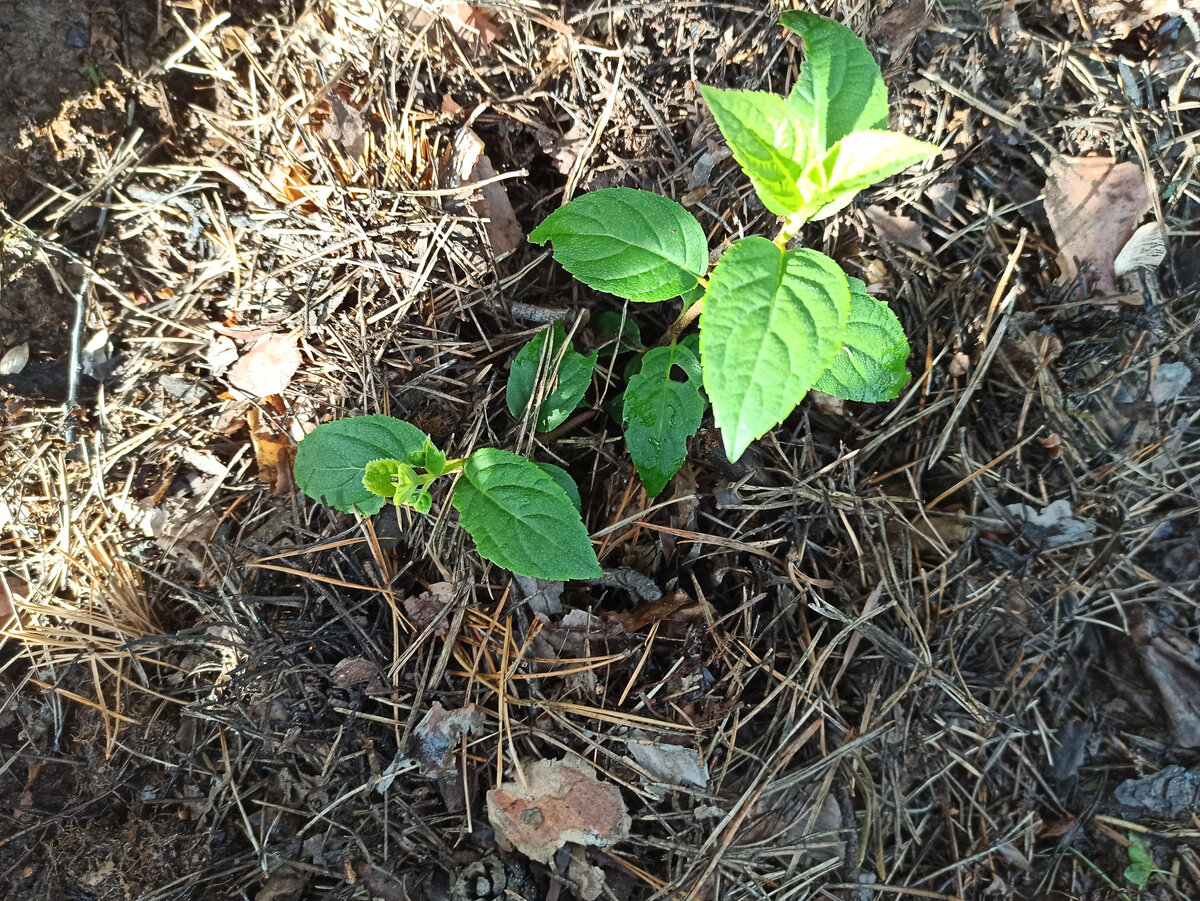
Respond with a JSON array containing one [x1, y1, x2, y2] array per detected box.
[[487, 757, 631, 864]]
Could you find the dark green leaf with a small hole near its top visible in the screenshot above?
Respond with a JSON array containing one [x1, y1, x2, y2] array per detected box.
[[622, 344, 704, 498]]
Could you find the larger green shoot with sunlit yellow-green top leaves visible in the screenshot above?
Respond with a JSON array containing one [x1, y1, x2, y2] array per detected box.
[[525, 12, 937, 497]]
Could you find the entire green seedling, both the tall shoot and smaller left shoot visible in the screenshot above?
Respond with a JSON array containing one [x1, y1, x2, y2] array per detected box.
[[295, 12, 937, 579]]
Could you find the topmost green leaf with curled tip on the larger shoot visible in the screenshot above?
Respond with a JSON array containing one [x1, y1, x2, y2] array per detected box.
[[779, 11, 888, 156]]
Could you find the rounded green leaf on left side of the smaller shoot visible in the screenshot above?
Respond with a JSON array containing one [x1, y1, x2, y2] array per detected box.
[[294, 415, 426, 513]]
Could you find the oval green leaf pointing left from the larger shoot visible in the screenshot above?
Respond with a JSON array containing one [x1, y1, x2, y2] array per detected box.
[[529, 187, 708, 302]]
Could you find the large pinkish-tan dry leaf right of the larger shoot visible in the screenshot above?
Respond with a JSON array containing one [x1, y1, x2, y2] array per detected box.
[[1045, 156, 1151, 294]]
